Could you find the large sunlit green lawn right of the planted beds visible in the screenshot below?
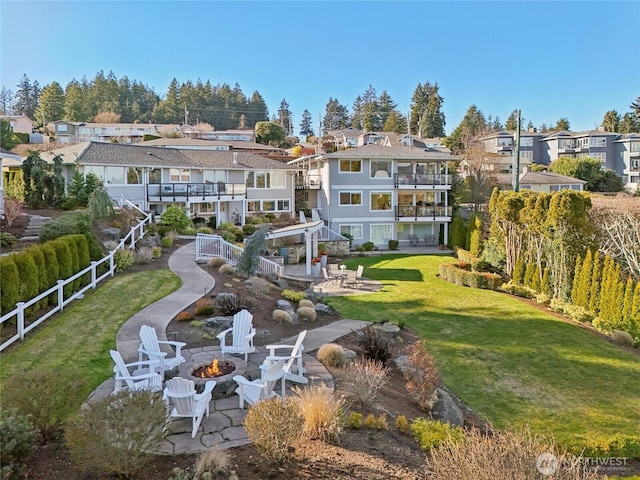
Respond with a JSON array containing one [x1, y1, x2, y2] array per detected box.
[[327, 255, 640, 454]]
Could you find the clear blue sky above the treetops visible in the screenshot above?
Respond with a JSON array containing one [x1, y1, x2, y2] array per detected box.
[[0, 0, 640, 133]]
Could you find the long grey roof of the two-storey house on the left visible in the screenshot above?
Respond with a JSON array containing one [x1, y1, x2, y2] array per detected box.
[[78, 142, 297, 170]]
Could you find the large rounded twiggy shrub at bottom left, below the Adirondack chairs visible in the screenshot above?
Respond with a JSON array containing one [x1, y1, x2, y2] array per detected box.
[[66, 390, 168, 477]]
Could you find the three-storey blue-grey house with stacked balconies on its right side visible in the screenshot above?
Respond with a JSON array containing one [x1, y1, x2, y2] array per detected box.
[[289, 145, 456, 248]]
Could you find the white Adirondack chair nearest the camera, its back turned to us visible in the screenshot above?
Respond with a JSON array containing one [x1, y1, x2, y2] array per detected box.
[[162, 377, 216, 438]]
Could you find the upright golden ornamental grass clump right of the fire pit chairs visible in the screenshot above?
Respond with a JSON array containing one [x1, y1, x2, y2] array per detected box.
[[294, 385, 344, 442]]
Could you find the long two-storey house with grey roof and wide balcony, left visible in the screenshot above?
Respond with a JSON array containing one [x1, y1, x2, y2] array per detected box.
[[77, 142, 298, 225]]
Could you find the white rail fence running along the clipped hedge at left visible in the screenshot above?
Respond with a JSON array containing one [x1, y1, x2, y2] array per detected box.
[[0, 213, 151, 352]]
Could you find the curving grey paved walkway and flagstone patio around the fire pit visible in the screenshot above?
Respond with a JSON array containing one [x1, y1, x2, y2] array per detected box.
[[89, 243, 369, 454]]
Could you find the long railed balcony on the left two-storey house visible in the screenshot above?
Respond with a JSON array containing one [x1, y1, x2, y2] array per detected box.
[[147, 182, 247, 202]]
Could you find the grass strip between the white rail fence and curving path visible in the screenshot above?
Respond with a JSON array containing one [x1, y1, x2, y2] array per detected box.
[[0, 269, 181, 410]]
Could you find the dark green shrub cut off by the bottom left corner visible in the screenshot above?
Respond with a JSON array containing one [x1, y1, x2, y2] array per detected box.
[[0, 406, 37, 478]]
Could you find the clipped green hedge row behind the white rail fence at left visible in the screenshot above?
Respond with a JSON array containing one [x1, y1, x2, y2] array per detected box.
[[0, 234, 91, 315]]
